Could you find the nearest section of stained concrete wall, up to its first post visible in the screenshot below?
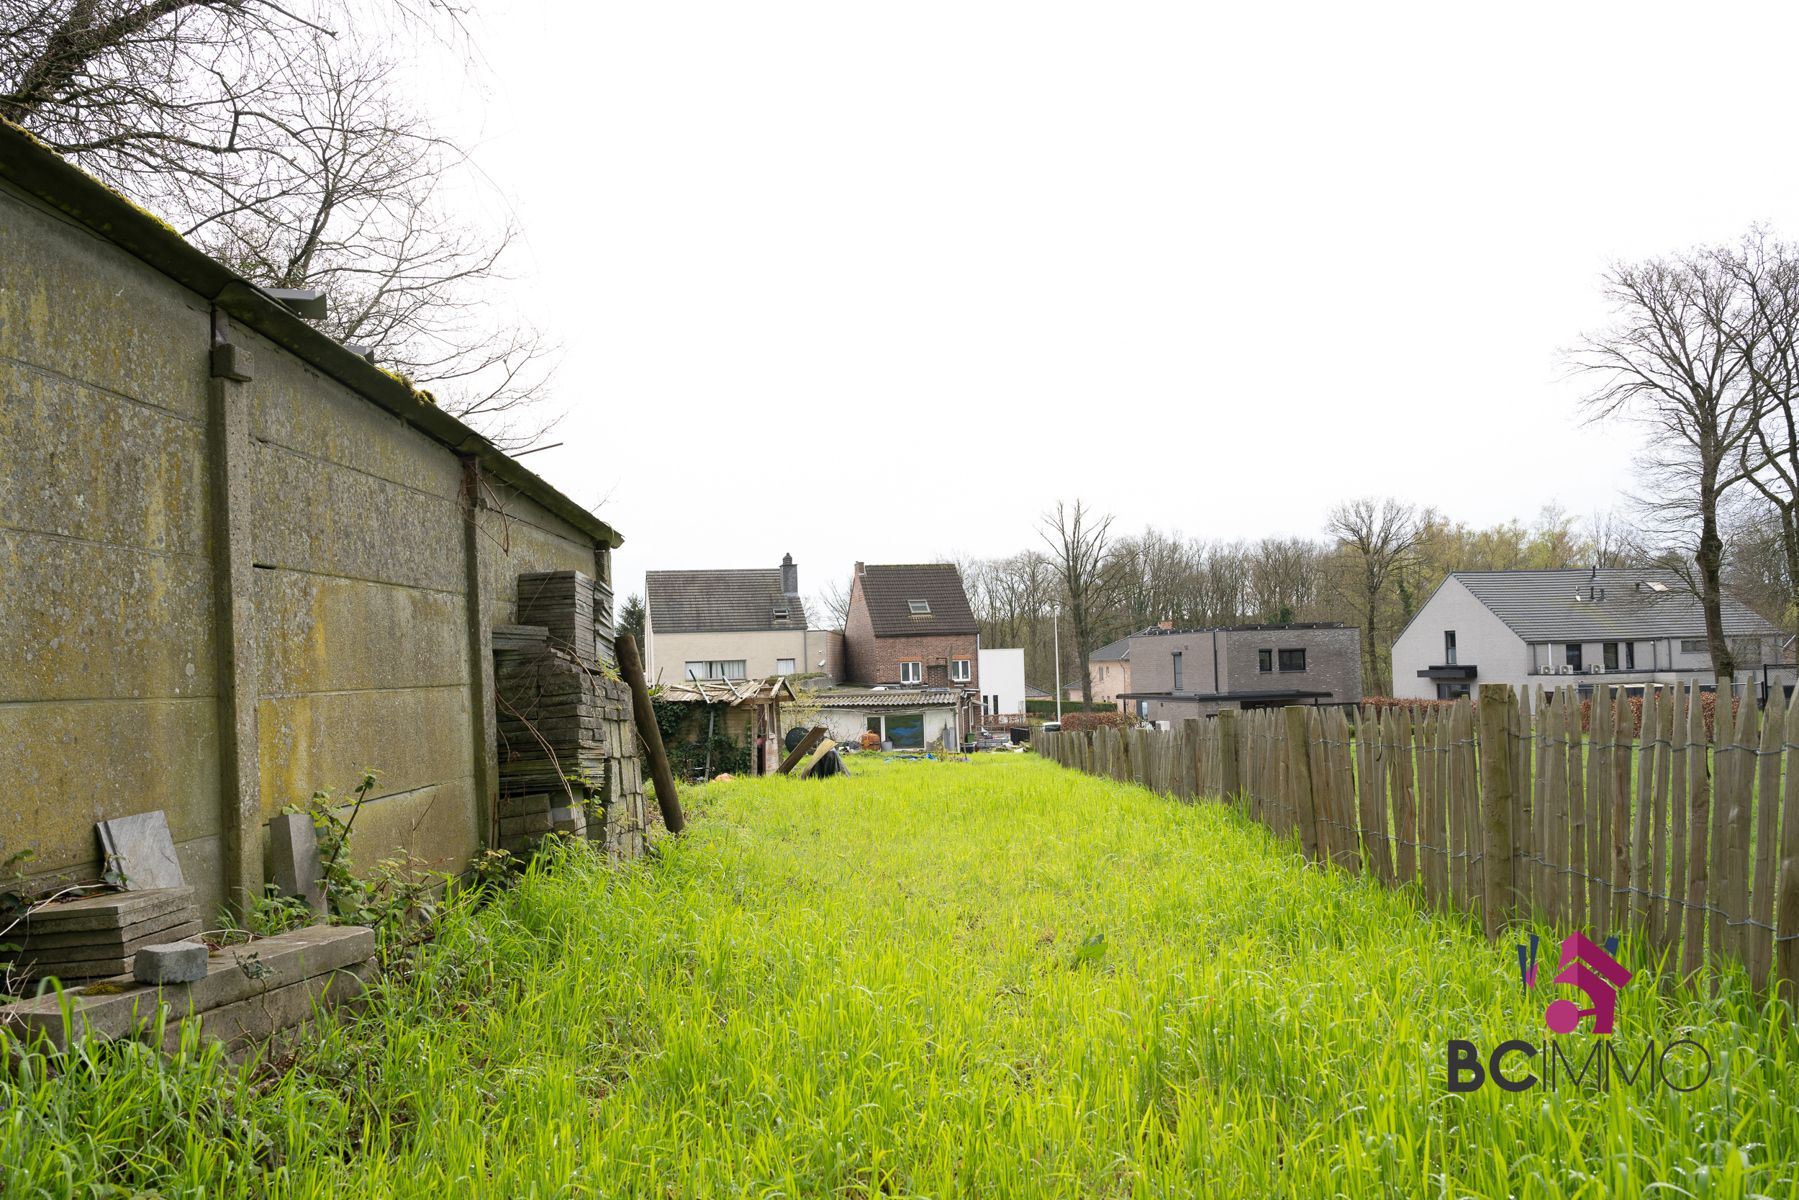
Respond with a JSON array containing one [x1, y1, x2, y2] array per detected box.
[[0, 178, 221, 910]]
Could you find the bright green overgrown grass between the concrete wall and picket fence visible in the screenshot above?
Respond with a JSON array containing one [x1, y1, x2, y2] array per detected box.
[[0, 756, 1799, 1198]]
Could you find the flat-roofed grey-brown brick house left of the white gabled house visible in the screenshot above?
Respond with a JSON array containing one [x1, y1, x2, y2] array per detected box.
[[1119, 622, 1362, 721]]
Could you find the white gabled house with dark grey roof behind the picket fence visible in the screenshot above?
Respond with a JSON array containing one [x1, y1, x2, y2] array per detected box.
[[1392, 567, 1794, 700]]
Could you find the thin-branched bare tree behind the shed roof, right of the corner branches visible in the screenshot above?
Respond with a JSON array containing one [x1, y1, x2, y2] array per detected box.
[[194, 38, 554, 450]]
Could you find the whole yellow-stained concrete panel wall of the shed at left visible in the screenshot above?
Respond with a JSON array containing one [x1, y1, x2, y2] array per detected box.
[[0, 141, 617, 918]]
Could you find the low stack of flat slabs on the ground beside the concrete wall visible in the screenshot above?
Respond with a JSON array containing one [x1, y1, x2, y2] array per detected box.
[[0, 887, 200, 981]]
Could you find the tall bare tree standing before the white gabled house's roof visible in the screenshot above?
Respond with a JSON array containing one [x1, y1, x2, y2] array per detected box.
[[1574, 250, 1761, 689]]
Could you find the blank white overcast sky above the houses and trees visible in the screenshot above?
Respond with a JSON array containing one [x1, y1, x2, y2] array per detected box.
[[432, 0, 1799, 611]]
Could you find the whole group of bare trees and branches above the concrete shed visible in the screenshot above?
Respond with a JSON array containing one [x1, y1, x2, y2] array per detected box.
[[0, 0, 554, 448]]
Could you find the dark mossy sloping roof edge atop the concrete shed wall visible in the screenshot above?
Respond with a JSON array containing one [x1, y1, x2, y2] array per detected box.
[[0, 121, 624, 549]]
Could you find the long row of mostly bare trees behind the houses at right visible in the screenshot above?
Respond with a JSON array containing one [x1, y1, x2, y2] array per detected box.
[[985, 228, 1799, 698]]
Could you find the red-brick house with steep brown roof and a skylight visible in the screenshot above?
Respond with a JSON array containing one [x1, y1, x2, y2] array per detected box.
[[844, 563, 980, 736]]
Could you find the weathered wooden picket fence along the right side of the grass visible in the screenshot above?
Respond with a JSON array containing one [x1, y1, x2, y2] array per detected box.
[[1038, 685, 1799, 999]]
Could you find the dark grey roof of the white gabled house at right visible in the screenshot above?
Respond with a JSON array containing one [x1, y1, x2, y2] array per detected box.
[[1450, 567, 1779, 642]]
